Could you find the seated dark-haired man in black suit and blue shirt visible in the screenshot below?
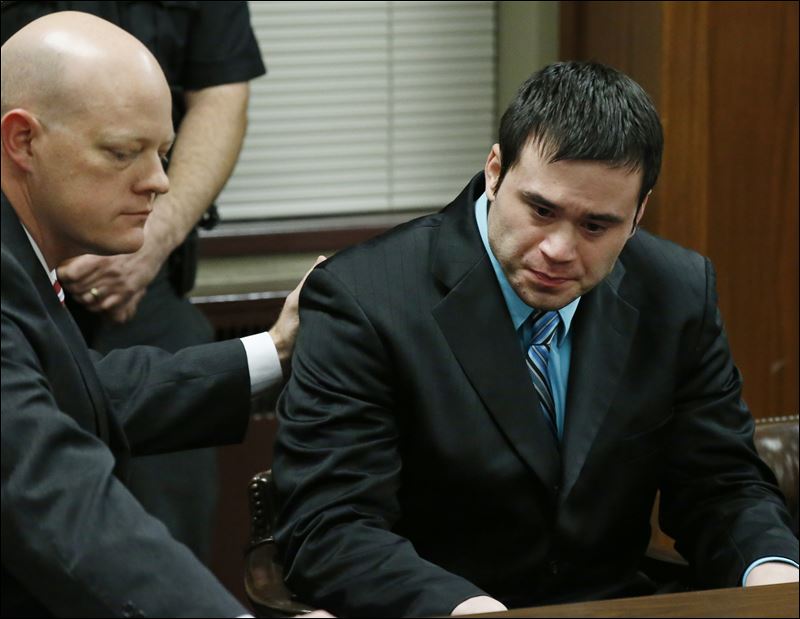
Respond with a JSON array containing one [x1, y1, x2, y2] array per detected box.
[[274, 63, 798, 616]]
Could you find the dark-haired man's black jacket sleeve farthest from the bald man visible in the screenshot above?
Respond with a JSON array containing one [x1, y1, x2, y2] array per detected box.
[[660, 260, 798, 587]]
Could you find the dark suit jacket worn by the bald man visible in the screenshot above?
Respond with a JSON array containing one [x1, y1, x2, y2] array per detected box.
[[1, 195, 250, 617]]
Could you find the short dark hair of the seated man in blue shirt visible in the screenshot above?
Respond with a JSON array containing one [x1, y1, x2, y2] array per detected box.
[[495, 62, 664, 206]]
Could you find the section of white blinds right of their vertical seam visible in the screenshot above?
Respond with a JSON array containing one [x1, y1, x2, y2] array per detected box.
[[388, 2, 495, 208]]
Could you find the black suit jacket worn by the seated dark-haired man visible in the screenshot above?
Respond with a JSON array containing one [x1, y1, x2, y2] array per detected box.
[[274, 175, 797, 616]]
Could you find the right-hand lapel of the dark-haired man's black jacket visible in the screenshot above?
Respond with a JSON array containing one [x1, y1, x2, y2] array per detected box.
[[561, 261, 639, 501]]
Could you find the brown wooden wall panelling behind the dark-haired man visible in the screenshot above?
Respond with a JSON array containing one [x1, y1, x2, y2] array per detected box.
[[560, 2, 798, 417]]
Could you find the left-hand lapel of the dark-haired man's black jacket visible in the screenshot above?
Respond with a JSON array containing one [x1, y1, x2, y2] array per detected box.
[[432, 174, 561, 486]]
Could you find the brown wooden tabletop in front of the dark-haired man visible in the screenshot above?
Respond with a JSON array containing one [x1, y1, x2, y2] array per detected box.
[[468, 583, 798, 617]]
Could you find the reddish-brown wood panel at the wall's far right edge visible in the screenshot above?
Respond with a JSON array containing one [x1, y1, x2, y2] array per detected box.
[[707, 2, 798, 416]]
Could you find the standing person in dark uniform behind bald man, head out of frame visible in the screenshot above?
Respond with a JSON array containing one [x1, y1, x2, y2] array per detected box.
[[2, 0, 265, 563]]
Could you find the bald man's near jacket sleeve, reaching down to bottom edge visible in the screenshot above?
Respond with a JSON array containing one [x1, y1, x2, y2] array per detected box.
[[0, 318, 244, 617]]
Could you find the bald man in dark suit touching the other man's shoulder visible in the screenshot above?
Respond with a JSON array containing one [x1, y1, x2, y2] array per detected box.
[[2, 12, 318, 617]]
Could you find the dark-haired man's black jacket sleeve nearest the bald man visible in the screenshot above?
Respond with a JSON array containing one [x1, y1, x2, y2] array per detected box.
[[273, 268, 484, 616]]
